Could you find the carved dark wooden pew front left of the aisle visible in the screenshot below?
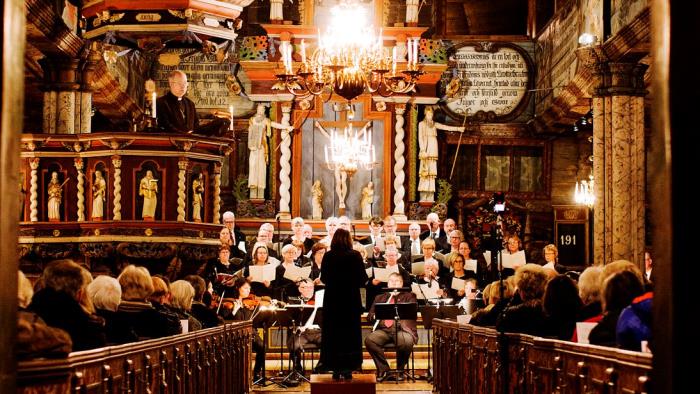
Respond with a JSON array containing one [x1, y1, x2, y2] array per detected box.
[[17, 322, 253, 394]]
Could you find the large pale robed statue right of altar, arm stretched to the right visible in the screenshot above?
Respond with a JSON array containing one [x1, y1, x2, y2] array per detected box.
[[418, 107, 464, 202]]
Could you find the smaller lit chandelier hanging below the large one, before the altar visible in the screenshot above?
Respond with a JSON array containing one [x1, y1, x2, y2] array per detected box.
[[325, 125, 375, 175]]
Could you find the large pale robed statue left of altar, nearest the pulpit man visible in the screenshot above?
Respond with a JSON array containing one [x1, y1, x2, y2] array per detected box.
[[248, 104, 294, 199]]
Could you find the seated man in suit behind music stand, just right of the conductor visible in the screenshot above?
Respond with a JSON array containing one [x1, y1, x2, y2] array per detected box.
[[365, 272, 418, 381]]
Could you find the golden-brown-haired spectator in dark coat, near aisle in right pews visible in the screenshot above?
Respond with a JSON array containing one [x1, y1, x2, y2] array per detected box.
[[496, 264, 547, 336]]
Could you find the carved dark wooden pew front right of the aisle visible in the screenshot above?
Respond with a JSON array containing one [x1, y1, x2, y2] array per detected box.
[[433, 320, 652, 394]]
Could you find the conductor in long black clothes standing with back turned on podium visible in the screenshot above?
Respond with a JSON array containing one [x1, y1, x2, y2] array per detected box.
[[321, 229, 368, 380]]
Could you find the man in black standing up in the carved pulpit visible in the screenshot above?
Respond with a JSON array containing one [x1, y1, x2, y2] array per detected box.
[[156, 70, 230, 136]]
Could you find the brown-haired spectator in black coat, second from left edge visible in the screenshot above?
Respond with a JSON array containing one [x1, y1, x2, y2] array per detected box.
[[29, 260, 106, 351]]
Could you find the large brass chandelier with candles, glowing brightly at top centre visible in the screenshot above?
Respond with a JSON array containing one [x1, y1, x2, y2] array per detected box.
[[273, 3, 423, 101]]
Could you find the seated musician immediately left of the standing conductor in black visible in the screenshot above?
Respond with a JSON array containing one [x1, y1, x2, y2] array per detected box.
[[287, 279, 321, 375]]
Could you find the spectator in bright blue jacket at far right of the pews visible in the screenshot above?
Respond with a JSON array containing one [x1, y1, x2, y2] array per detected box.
[[616, 291, 654, 351]]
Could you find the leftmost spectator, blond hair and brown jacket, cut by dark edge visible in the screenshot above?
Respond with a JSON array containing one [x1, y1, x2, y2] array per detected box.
[[15, 271, 73, 360]]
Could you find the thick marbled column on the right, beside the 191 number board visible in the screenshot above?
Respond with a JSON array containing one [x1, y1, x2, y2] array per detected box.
[[593, 63, 647, 265]]
